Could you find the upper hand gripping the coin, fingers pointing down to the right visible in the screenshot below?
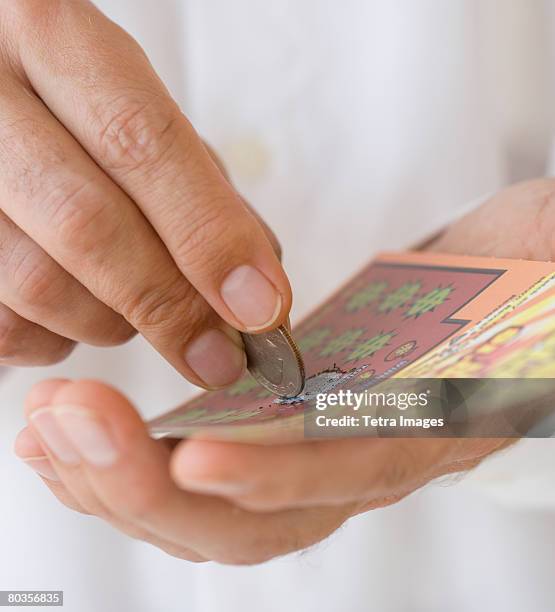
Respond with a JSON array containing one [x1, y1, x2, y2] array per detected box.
[[0, 0, 291, 388]]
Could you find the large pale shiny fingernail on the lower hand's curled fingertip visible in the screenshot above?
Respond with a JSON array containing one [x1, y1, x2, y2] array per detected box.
[[53, 406, 118, 467]]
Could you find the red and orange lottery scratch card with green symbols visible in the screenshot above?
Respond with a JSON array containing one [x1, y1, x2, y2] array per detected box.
[[149, 252, 555, 443]]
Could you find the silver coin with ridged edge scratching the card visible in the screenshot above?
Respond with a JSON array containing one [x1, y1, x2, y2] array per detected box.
[[241, 325, 305, 397]]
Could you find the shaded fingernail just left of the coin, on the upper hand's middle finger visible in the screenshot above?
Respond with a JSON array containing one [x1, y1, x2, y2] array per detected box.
[[185, 329, 246, 387]]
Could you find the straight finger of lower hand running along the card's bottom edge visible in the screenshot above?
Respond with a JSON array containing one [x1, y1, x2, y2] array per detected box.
[[171, 438, 460, 511]]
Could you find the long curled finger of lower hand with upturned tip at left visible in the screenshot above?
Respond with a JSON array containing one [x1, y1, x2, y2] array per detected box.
[[26, 381, 351, 563]]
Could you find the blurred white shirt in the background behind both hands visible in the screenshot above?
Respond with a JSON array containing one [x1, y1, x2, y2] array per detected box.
[[0, 0, 555, 612]]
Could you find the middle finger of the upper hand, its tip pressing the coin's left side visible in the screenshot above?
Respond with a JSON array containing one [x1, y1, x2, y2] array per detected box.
[[0, 78, 245, 387]]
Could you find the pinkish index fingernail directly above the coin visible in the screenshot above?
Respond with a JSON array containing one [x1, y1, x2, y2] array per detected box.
[[221, 266, 281, 331]]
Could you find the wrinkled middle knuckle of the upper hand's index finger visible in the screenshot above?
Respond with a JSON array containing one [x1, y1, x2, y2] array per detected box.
[[94, 94, 180, 171]]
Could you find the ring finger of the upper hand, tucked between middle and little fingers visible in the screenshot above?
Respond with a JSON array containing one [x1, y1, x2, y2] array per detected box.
[[0, 212, 133, 345]]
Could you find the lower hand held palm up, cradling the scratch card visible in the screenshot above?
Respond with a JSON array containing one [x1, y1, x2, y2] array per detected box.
[[15, 179, 555, 564]]
